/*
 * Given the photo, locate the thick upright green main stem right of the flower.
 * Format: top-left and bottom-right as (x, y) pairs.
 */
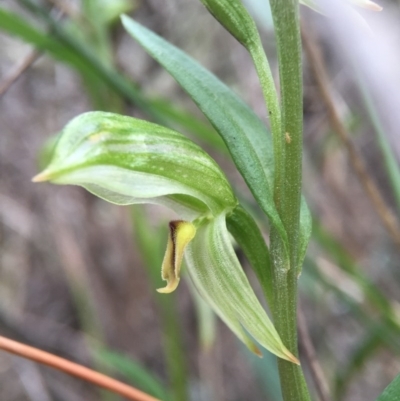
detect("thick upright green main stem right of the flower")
(270, 0), (310, 401)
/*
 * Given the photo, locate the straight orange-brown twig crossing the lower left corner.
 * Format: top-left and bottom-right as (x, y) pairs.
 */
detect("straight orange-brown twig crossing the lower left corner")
(0, 336), (160, 401)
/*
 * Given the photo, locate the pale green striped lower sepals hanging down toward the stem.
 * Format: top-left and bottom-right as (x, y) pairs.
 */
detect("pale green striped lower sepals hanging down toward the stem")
(186, 214), (298, 363)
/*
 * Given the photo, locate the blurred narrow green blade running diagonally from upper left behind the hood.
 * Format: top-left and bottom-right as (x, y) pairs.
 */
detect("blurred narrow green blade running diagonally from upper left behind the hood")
(0, 8), (244, 150)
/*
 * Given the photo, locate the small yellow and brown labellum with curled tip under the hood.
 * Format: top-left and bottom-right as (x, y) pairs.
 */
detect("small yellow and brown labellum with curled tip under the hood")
(157, 220), (196, 293)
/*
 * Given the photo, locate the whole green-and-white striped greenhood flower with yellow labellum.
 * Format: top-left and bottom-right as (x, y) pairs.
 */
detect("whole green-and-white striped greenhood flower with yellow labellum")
(33, 112), (298, 363)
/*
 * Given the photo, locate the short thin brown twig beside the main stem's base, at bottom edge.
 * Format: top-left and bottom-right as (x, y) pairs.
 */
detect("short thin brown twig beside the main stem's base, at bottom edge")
(297, 308), (330, 401)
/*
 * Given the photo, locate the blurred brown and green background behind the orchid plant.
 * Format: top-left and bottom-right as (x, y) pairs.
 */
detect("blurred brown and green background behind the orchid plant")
(0, 0), (400, 401)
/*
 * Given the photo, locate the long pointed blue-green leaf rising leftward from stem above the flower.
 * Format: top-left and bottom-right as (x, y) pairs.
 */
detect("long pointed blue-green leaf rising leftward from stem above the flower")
(122, 15), (286, 243)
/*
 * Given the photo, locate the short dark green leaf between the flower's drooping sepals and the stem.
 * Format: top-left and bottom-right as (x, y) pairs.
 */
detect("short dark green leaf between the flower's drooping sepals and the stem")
(226, 205), (274, 311)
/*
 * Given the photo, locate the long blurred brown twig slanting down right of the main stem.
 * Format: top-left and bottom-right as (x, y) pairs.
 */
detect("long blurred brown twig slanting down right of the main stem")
(301, 26), (400, 246)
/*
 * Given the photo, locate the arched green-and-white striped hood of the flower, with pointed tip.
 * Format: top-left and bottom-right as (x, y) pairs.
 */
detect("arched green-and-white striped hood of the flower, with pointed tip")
(34, 112), (237, 217)
